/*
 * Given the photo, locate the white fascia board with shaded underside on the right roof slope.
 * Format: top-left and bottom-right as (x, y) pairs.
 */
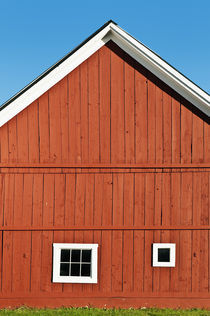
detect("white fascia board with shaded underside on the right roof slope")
(110, 24), (210, 116)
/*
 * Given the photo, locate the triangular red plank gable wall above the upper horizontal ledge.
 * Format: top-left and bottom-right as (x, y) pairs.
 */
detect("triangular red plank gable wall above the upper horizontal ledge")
(1, 44), (210, 164)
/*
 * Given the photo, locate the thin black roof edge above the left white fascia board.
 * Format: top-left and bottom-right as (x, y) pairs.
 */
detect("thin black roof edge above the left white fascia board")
(0, 20), (117, 111)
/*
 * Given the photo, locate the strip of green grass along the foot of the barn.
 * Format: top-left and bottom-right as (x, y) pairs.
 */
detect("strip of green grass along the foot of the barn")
(0, 307), (210, 316)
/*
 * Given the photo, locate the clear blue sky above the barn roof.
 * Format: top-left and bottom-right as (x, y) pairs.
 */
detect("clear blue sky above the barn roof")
(0, 0), (210, 105)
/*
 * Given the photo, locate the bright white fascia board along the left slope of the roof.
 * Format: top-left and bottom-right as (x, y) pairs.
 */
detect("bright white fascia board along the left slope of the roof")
(0, 23), (114, 127)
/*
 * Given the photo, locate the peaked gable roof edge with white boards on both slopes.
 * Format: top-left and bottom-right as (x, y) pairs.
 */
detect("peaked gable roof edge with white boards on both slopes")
(0, 20), (210, 127)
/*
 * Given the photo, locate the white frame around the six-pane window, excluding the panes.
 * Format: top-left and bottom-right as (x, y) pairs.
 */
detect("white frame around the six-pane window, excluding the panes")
(53, 243), (98, 283)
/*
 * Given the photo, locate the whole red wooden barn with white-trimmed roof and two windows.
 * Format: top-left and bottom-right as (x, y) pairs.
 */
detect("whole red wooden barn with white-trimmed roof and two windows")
(0, 21), (210, 308)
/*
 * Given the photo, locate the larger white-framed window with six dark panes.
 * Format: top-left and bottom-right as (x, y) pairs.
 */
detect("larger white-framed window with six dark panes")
(53, 243), (98, 283)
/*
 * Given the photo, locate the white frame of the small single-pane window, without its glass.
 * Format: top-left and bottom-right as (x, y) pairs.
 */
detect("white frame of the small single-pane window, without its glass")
(152, 243), (176, 267)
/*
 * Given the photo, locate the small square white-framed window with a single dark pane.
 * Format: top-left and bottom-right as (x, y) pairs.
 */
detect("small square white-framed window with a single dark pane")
(152, 243), (176, 267)
